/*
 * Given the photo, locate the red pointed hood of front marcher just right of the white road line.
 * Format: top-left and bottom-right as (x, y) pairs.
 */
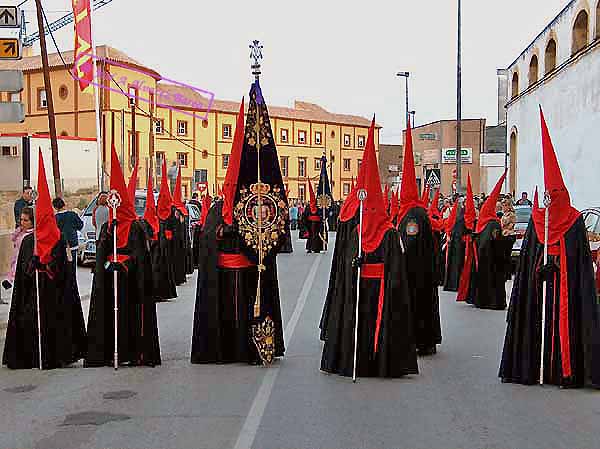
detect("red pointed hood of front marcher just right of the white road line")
(340, 117), (393, 253)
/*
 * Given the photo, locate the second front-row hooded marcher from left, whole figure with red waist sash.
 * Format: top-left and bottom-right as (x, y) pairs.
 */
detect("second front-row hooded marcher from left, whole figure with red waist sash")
(84, 146), (164, 368)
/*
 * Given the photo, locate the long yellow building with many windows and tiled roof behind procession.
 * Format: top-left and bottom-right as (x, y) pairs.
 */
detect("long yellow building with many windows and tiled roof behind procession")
(0, 46), (381, 199)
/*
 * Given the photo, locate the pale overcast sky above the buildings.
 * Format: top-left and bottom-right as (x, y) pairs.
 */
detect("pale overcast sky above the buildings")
(23, 0), (568, 143)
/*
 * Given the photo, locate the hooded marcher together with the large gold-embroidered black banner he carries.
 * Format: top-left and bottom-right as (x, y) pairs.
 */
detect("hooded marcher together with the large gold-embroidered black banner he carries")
(191, 86), (289, 364)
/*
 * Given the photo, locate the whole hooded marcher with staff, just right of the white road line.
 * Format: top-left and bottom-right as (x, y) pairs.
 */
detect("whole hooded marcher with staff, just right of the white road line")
(320, 116), (418, 377)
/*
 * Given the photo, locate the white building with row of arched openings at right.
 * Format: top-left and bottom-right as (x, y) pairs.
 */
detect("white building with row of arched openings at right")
(505, 0), (600, 209)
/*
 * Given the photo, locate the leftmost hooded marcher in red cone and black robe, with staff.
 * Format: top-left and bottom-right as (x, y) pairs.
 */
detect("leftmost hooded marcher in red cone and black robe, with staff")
(2, 151), (86, 369)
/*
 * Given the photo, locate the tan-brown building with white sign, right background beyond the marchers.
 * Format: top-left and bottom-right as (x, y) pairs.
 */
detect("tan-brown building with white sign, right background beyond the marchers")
(402, 119), (485, 195)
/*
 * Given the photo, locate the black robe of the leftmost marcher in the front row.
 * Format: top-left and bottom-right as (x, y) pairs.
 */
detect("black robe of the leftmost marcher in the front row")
(2, 235), (86, 369)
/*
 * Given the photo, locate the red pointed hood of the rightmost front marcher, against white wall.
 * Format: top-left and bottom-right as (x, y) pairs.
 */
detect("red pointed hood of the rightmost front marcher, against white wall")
(533, 106), (581, 245)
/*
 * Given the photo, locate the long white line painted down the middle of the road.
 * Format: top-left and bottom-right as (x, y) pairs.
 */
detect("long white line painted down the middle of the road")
(234, 255), (323, 449)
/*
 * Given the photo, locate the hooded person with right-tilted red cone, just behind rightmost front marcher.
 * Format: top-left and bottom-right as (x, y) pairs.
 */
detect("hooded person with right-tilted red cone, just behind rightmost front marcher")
(469, 170), (506, 310)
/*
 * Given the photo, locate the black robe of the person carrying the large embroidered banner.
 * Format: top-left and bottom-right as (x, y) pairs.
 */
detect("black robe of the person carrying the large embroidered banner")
(191, 201), (285, 364)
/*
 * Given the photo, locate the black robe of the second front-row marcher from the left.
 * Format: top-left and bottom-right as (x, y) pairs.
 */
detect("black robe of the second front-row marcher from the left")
(84, 221), (161, 367)
